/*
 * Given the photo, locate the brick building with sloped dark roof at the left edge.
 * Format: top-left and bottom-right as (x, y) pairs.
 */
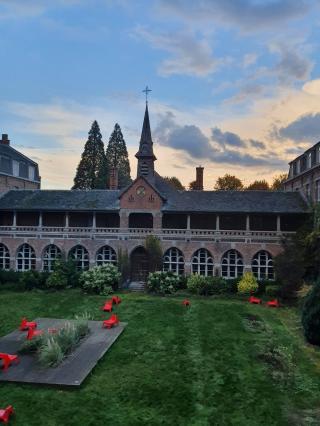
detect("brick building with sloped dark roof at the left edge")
(0, 134), (40, 192)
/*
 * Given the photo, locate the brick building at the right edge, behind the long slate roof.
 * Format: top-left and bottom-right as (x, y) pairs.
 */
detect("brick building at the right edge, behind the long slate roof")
(284, 142), (320, 202)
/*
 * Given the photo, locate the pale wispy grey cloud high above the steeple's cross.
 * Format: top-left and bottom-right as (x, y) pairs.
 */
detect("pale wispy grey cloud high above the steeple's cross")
(133, 27), (223, 77)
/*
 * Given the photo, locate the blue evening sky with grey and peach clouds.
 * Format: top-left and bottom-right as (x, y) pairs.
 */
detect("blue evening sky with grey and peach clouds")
(0, 0), (320, 189)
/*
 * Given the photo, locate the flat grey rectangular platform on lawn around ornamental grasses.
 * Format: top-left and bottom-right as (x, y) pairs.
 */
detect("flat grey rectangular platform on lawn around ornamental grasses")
(0, 318), (127, 386)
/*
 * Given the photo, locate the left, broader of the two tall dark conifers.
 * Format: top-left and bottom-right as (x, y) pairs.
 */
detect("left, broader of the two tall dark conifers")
(72, 121), (106, 189)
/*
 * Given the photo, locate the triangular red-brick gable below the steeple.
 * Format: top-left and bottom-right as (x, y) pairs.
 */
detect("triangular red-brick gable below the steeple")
(120, 177), (163, 210)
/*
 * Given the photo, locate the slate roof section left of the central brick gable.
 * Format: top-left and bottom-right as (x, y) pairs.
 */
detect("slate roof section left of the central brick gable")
(0, 189), (120, 211)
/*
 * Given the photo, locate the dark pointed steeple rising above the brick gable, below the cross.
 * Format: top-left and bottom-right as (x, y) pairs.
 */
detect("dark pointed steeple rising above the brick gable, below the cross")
(136, 102), (157, 178)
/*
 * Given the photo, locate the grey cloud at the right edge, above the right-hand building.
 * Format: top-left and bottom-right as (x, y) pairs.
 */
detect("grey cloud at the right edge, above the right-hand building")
(272, 112), (320, 143)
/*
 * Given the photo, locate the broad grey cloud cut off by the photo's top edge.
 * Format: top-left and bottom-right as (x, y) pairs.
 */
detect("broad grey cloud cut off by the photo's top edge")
(159, 0), (314, 32)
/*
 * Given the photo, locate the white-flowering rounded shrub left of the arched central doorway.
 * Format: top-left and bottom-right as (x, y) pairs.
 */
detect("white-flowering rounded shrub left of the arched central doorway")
(80, 263), (121, 294)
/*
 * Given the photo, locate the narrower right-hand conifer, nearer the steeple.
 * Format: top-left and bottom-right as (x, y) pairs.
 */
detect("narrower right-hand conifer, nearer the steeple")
(106, 123), (131, 188)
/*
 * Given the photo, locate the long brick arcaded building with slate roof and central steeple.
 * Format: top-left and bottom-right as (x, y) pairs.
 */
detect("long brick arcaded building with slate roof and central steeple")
(0, 106), (308, 281)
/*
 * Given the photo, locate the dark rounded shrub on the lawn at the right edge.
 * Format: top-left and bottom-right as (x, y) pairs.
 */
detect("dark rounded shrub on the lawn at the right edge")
(302, 280), (320, 346)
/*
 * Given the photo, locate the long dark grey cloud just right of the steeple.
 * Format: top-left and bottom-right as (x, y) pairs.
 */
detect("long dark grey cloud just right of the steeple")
(154, 112), (286, 167)
